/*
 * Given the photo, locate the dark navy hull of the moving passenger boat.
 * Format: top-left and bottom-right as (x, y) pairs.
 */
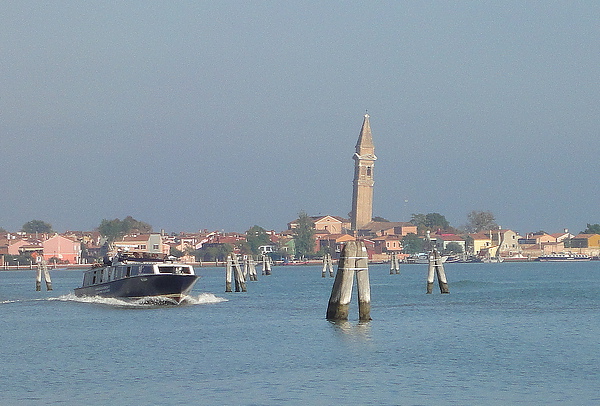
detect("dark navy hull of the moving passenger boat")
(74, 274), (199, 303)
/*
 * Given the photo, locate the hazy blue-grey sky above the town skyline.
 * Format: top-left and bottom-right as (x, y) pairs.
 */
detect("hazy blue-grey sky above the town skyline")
(0, 0), (600, 233)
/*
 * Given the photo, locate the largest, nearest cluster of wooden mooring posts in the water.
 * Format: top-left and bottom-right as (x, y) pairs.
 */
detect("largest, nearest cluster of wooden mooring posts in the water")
(327, 241), (371, 321)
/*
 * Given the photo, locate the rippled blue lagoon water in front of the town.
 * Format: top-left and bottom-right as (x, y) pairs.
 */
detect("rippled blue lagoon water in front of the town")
(0, 262), (600, 405)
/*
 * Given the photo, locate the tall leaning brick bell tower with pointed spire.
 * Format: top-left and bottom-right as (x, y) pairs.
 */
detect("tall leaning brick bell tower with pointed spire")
(350, 114), (377, 231)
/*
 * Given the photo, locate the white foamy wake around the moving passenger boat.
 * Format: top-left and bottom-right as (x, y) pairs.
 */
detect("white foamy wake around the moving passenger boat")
(46, 293), (227, 308)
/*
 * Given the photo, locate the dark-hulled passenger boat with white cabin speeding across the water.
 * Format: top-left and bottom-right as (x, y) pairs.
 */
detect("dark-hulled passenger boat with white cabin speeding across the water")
(74, 254), (199, 304)
